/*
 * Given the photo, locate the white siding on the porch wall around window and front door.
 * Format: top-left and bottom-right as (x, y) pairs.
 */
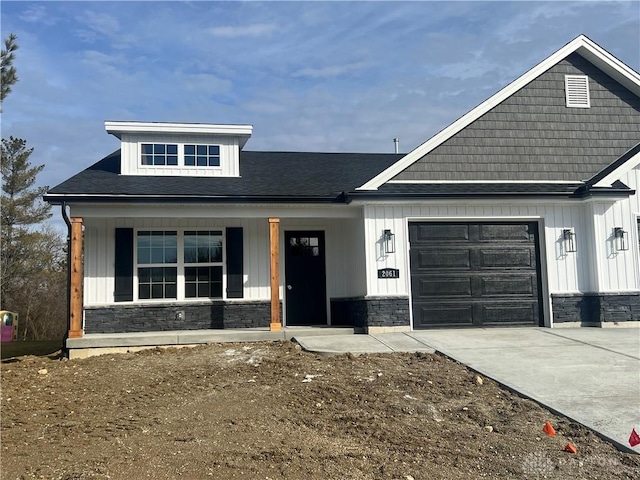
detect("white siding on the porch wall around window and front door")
(84, 217), (366, 306)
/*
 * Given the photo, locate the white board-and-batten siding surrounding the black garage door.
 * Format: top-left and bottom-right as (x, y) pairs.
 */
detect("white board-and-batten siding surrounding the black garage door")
(364, 202), (592, 296)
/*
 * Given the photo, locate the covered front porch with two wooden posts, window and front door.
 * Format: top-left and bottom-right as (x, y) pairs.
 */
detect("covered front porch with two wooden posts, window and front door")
(68, 204), (384, 347)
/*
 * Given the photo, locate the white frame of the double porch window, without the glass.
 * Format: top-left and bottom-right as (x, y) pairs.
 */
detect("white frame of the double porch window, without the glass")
(133, 227), (227, 303)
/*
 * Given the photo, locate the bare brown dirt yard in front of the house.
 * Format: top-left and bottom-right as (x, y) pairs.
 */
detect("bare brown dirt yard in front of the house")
(1, 342), (640, 480)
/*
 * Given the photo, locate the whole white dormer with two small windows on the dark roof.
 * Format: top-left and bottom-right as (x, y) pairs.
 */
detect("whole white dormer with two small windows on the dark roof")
(104, 121), (253, 177)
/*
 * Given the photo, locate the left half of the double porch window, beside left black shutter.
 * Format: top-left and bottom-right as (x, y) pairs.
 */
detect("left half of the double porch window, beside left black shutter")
(137, 231), (178, 300)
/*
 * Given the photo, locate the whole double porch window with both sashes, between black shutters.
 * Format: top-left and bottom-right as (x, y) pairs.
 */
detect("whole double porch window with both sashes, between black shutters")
(136, 230), (223, 300)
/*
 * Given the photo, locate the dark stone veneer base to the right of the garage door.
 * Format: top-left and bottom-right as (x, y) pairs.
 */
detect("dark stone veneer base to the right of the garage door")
(551, 292), (640, 327)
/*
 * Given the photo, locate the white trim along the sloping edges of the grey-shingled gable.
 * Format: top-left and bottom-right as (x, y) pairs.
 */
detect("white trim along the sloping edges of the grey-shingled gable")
(356, 35), (640, 190)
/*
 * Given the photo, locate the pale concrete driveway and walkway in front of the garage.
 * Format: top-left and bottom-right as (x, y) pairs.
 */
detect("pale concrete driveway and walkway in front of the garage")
(295, 328), (640, 453)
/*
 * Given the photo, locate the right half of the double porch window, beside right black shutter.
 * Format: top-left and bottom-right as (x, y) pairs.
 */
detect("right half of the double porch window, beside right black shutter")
(184, 231), (222, 298)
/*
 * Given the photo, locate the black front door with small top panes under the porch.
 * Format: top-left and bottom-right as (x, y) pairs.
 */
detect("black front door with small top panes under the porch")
(284, 231), (327, 326)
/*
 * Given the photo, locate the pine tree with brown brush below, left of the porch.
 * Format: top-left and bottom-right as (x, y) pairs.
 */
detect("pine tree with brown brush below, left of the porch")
(0, 137), (66, 339)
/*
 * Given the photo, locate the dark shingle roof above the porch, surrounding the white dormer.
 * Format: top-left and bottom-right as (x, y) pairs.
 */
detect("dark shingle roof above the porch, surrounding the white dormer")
(45, 150), (403, 202)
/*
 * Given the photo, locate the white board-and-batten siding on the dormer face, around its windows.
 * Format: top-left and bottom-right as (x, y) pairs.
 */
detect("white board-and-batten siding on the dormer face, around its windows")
(121, 133), (240, 177)
